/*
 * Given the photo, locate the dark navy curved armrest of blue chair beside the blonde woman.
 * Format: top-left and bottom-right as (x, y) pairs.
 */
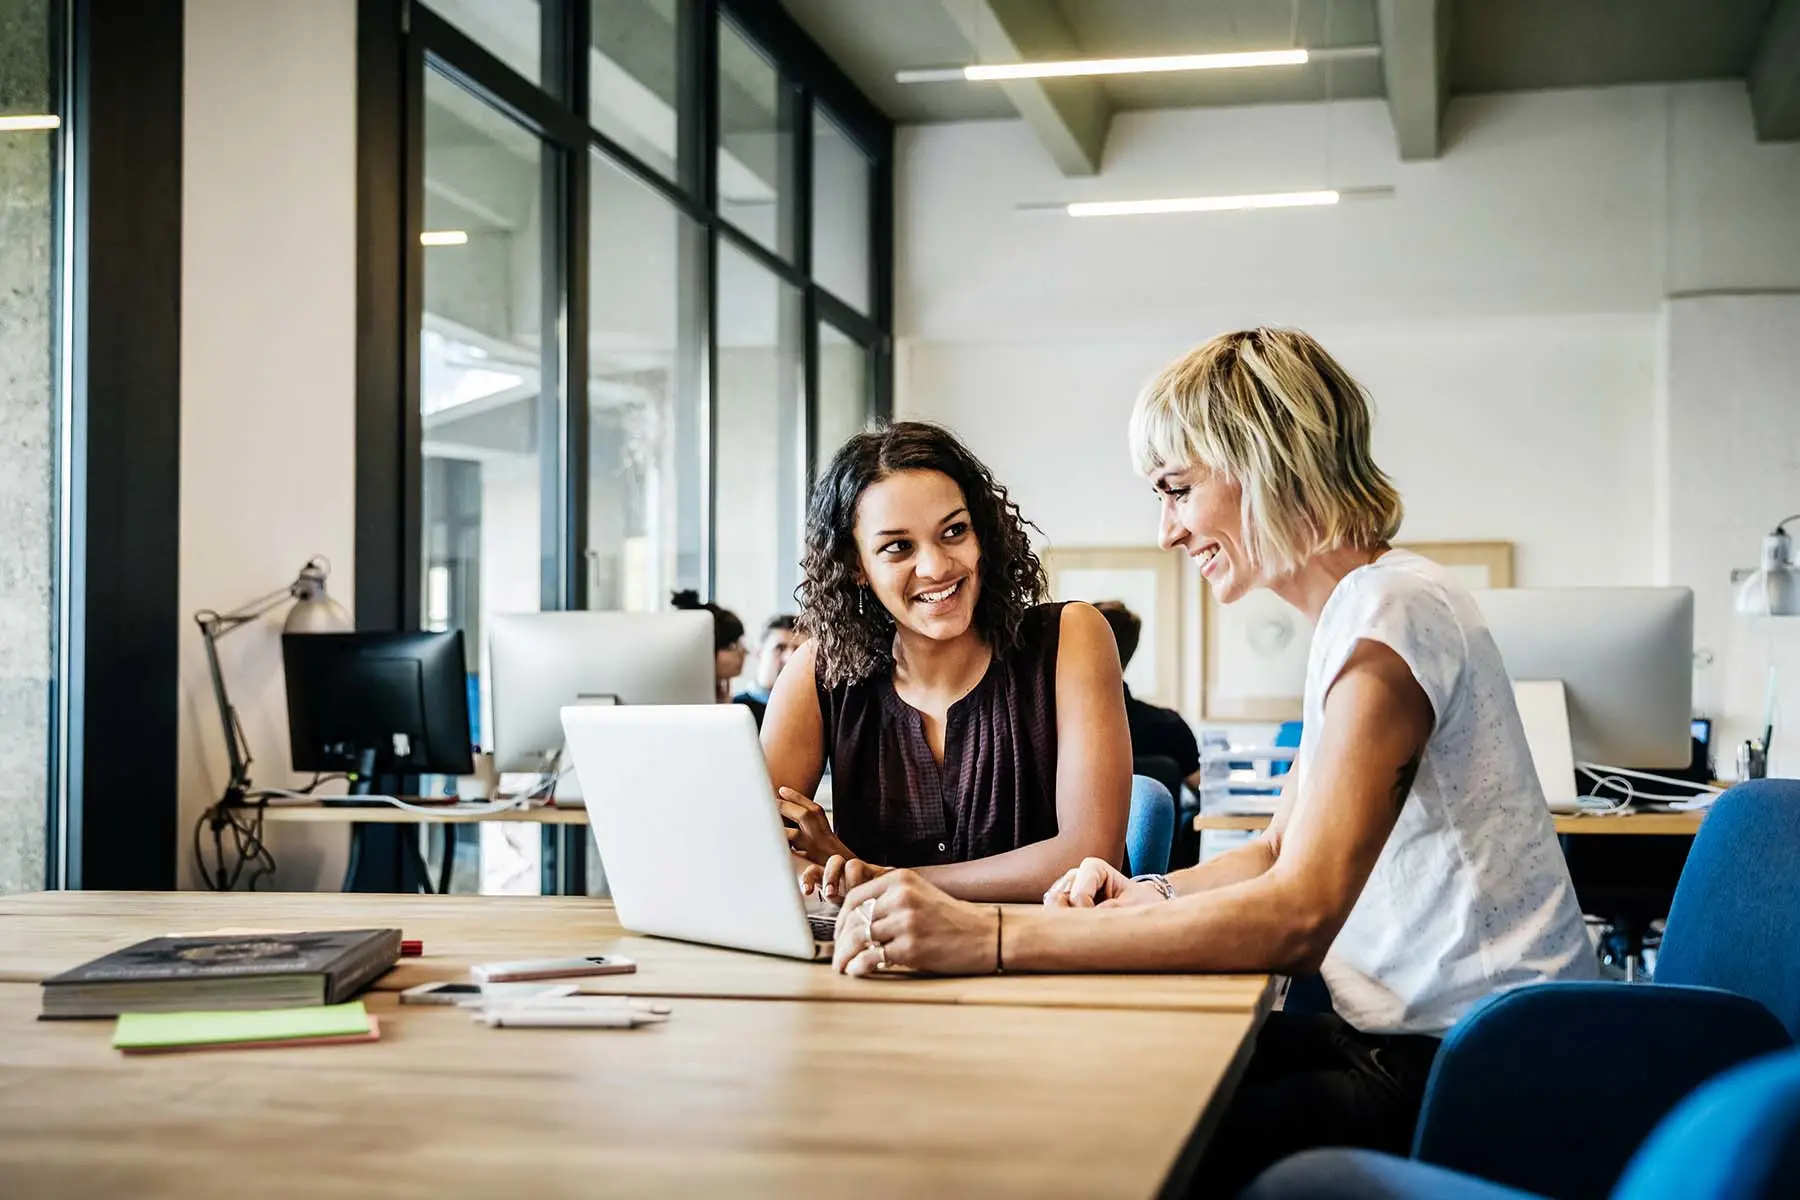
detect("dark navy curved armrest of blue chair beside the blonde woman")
(1413, 982), (1793, 1200)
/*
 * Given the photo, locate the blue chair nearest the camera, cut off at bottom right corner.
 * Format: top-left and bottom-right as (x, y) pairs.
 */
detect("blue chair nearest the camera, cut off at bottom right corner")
(1240, 1051), (1800, 1200)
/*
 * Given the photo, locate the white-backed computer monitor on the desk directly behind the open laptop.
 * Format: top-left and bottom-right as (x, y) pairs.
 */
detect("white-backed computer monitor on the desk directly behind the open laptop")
(488, 612), (716, 772)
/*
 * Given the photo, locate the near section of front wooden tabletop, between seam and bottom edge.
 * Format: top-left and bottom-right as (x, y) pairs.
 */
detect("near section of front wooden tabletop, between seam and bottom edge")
(0, 984), (1255, 1200)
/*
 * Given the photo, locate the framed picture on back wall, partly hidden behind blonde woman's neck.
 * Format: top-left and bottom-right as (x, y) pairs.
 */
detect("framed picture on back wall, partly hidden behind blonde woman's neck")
(1201, 542), (1512, 723)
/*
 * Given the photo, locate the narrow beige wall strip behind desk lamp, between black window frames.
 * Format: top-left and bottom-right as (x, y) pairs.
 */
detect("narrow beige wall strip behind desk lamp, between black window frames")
(178, 0), (356, 891)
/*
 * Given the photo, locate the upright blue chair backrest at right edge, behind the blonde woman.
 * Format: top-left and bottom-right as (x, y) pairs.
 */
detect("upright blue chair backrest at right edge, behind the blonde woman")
(1656, 779), (1800, 1038)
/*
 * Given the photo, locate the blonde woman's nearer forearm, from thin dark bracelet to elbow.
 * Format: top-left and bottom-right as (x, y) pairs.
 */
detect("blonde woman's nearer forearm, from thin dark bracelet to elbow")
(1003, 873), (1330, 973)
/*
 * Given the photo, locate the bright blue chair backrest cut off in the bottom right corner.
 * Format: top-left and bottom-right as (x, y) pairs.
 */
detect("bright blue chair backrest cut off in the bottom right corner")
(1613, 1051), (1800, 1200)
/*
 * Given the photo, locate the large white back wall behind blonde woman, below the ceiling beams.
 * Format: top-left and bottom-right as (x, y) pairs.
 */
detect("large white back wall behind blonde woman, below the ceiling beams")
(896, 83), (1800, 744)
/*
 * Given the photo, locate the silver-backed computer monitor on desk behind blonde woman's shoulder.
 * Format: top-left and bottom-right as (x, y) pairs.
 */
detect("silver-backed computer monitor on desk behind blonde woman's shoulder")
(1474, 588), (1694, 770)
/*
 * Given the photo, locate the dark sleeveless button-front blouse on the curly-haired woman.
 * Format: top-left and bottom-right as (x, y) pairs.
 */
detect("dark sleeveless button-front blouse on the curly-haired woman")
(819, 604), (1062, 867)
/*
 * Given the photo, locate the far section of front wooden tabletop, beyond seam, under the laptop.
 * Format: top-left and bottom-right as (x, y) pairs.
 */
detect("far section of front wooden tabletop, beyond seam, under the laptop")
(0, 892), (1271, 1013)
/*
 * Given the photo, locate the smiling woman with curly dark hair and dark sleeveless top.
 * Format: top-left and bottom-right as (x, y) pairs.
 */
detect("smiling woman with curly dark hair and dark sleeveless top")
(763, 421), (1132, 901)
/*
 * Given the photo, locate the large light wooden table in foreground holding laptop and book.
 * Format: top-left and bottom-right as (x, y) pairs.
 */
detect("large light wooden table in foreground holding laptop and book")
(0, 892), (1269, 1200)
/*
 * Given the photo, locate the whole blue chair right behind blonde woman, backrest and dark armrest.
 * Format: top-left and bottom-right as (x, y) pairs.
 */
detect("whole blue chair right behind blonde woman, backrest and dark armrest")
(1413, 779), (1800, 1200)
